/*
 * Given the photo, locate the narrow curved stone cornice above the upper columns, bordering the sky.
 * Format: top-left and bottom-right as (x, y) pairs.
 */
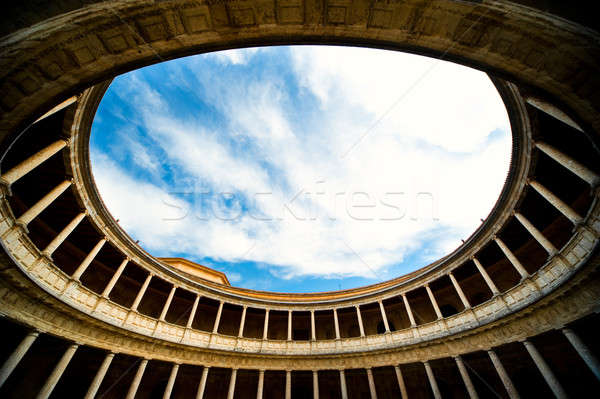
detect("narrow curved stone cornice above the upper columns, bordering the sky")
(65, 78), (533, 310)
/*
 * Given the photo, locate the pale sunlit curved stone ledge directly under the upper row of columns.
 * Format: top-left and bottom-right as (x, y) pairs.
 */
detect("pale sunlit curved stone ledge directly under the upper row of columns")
(0, 183), (600, 356)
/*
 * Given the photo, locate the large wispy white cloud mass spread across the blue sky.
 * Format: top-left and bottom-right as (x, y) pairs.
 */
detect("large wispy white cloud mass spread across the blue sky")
(93, 47), (511, 281)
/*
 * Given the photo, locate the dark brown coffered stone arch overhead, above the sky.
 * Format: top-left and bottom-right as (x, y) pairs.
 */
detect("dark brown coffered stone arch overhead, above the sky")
(0, 0), (600, 142)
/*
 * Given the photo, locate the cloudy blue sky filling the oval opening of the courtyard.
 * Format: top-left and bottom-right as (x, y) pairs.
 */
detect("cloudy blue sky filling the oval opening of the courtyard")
(90, 46), (511, 292)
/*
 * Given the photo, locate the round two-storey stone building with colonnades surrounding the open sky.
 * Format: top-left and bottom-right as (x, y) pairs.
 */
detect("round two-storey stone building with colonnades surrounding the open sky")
(0, 0), (600, 398)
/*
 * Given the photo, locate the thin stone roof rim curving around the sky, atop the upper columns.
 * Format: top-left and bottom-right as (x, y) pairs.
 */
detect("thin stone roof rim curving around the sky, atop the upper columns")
(70, 69), (531, 304)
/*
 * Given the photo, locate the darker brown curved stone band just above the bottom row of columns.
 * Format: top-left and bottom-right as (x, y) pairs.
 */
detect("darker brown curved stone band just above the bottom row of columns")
(0, 239), (600, 370)
